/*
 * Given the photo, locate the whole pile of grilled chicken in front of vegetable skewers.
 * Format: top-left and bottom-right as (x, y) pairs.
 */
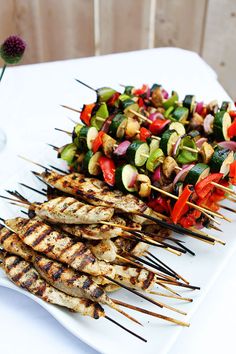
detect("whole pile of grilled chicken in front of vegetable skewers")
(0, 170), (195, 340)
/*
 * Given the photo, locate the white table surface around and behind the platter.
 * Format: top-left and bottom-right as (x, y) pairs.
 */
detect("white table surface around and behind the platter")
(0, 48), (236, 354)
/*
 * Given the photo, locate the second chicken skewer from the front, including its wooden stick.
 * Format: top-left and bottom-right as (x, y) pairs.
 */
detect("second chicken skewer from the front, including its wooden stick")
(0, 225), (188, 326)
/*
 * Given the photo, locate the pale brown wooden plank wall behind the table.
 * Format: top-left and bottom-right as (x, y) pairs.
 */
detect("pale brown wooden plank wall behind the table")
(0, 0), (236, 98)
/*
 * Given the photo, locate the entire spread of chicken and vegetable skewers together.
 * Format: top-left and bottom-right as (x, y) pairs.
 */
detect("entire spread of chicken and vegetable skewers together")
(0, 83), (236, 341)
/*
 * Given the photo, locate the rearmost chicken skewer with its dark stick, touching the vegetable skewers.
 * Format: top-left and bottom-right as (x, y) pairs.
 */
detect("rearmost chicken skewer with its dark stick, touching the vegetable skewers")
(30, 169), (216, 238)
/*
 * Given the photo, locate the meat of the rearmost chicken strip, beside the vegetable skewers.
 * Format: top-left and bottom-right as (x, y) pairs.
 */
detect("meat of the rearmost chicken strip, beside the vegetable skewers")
(41, 171), (152, 214)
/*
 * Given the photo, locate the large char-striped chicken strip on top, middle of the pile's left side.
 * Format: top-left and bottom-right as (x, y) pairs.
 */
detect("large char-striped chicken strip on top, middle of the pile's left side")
(6, 217), (114, 277)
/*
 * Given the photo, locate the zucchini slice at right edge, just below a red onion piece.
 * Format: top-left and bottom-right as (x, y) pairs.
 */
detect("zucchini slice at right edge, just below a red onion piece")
(210, 149), (234, 177)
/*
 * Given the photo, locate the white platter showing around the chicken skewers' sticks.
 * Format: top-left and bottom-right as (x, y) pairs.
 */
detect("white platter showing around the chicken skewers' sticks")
(0, 167), (236, 354)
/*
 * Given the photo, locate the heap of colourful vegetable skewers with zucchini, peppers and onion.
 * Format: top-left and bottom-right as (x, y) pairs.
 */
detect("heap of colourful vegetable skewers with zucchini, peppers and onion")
(57, 80), (236, 229)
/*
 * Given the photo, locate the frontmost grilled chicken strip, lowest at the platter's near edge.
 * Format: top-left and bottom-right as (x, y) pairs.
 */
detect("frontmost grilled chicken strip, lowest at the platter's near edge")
(3, 256), (105, 319)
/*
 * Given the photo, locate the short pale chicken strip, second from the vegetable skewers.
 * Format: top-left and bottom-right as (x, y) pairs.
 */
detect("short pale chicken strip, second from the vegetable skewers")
(34, 196), (114, 224)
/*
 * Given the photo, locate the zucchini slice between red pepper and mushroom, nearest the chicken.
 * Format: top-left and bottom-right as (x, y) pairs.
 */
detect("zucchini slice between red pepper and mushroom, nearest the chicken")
(115, 165), (138, 192)
